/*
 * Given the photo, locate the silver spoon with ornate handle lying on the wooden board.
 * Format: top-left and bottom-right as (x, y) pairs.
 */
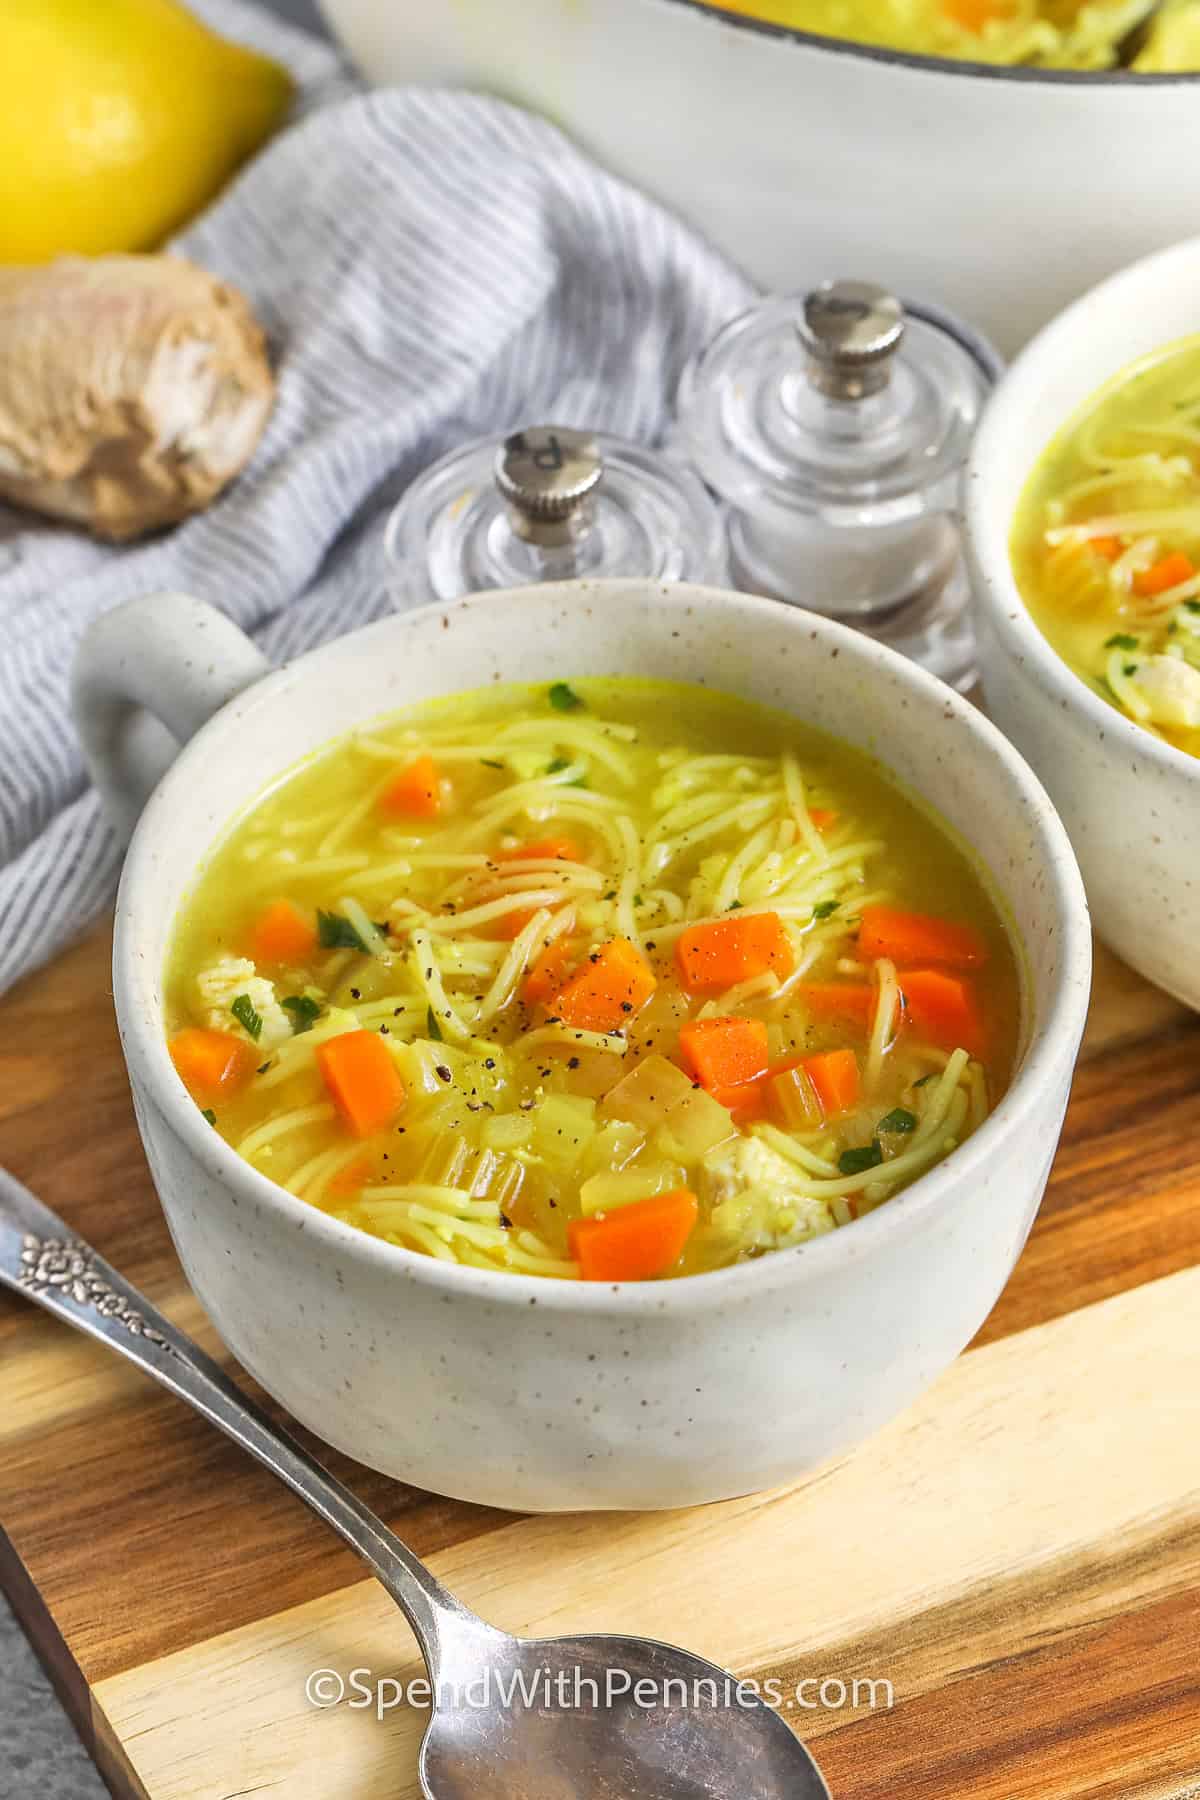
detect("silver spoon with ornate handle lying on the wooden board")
(0, 1170), (829, 1800)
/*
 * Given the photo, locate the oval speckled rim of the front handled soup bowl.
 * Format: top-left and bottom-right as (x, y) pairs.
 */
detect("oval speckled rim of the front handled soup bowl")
(113, 580), (1092, 1318)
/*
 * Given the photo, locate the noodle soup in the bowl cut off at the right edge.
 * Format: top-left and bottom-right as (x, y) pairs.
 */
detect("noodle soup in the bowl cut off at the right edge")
(1013, 337), (1200, 756)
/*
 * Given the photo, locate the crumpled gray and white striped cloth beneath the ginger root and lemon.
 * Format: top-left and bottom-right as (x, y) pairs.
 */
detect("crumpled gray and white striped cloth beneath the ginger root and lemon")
(0, 0), (752, 992)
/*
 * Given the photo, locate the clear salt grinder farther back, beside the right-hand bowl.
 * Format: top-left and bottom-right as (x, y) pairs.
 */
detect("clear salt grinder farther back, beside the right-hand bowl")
(673, 281), (1002, 689)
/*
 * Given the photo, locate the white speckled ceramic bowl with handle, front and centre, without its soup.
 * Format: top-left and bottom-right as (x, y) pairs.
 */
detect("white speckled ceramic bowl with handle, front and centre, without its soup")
(76, 581), (1090, 1510)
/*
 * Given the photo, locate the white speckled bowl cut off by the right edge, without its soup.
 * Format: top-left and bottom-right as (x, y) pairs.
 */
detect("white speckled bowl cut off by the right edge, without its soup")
(966, 238), (1200, 1010)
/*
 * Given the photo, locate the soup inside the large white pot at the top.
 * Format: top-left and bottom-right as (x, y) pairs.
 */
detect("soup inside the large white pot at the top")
(707, 0), (1200, 70)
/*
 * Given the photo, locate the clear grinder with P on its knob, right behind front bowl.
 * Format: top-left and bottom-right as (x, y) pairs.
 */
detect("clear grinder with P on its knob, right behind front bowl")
(385, 425), (727, 605)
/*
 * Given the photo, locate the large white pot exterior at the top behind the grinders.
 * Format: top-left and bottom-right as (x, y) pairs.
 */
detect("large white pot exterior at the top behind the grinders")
(320, 0), (1200, 351)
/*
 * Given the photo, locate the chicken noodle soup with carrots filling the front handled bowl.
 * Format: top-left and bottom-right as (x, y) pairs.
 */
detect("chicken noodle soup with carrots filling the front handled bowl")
(167, 680), (1016, 1282)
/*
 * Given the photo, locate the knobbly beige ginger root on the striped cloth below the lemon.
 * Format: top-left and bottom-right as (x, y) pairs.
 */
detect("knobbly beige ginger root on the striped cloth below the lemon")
(0, 256), (275, 542)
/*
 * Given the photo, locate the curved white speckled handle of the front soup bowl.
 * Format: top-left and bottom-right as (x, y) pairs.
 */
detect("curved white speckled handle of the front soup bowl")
(72, 594), (270, 841)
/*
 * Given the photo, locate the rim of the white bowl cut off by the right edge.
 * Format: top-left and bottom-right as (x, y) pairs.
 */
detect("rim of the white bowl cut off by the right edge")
(964, 238), (1200, 799)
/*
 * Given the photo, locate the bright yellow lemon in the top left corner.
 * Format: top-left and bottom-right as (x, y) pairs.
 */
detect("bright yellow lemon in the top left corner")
(0, 0), (291, 263)
